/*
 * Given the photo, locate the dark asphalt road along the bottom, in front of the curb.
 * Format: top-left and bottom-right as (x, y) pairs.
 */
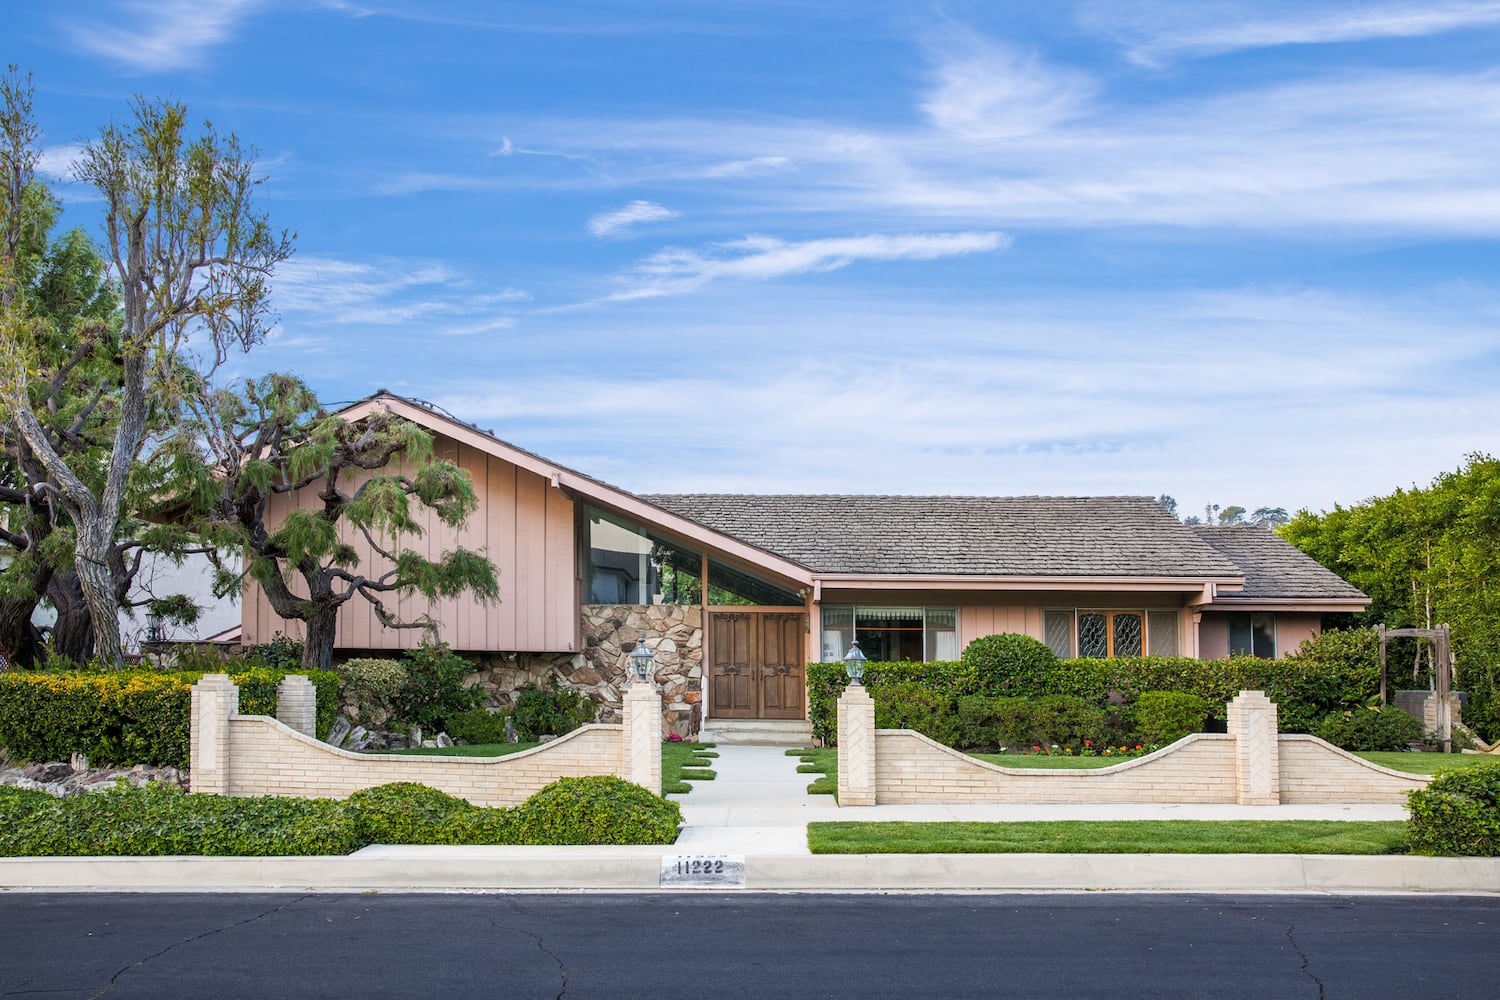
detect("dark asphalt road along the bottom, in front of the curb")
(0, 894), (1500, 1000)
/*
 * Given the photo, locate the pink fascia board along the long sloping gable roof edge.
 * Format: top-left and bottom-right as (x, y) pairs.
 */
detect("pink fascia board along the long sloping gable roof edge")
(339, 396), (813, 586)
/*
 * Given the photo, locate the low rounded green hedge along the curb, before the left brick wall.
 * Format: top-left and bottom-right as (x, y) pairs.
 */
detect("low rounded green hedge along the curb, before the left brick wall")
(0, 777), (683, 858)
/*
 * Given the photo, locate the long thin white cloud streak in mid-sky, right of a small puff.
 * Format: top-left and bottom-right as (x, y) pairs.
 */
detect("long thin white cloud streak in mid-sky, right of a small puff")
(608, 232), (1010, 301)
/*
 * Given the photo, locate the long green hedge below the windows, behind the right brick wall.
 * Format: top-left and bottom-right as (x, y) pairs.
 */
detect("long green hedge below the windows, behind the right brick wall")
(807, 628), (1380, 745)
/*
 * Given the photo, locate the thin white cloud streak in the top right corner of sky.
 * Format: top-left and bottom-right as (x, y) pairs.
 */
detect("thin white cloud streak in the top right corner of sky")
(1086, 0), (1500, 64)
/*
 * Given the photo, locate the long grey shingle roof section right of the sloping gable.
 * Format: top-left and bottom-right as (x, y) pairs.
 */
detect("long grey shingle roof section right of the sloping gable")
(642, 493), (1242, 577)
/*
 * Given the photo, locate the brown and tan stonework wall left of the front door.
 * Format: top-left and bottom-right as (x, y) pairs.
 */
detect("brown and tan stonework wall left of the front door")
(467, 604), (704, 738)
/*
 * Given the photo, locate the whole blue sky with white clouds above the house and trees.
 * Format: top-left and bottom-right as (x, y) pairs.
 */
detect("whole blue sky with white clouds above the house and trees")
(5, 0), (1500, 513)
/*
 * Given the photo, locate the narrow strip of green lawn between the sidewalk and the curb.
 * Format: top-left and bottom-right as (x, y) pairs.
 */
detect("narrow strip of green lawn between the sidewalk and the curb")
(807, 820), (1406, 855)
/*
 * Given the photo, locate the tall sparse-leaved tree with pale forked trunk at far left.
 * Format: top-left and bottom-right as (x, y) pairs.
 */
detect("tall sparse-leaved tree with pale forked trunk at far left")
(0, 78), (291, 664)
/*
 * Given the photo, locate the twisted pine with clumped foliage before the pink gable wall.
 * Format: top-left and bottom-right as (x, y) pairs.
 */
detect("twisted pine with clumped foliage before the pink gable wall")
(164, 375), (500, 669)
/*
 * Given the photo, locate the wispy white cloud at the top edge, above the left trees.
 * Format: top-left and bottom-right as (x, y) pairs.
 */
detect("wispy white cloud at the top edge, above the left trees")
(60, 0), (266, 73)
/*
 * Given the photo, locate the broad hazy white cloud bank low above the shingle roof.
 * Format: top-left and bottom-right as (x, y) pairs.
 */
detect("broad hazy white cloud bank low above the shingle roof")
(440, 286), (1500, 513)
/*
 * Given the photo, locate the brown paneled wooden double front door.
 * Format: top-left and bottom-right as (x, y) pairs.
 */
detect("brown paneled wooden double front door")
(708, 610), (807, 718)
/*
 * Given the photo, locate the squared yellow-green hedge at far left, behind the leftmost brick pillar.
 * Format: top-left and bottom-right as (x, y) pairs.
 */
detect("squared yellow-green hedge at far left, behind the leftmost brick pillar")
(0, 664), (339, 768)
